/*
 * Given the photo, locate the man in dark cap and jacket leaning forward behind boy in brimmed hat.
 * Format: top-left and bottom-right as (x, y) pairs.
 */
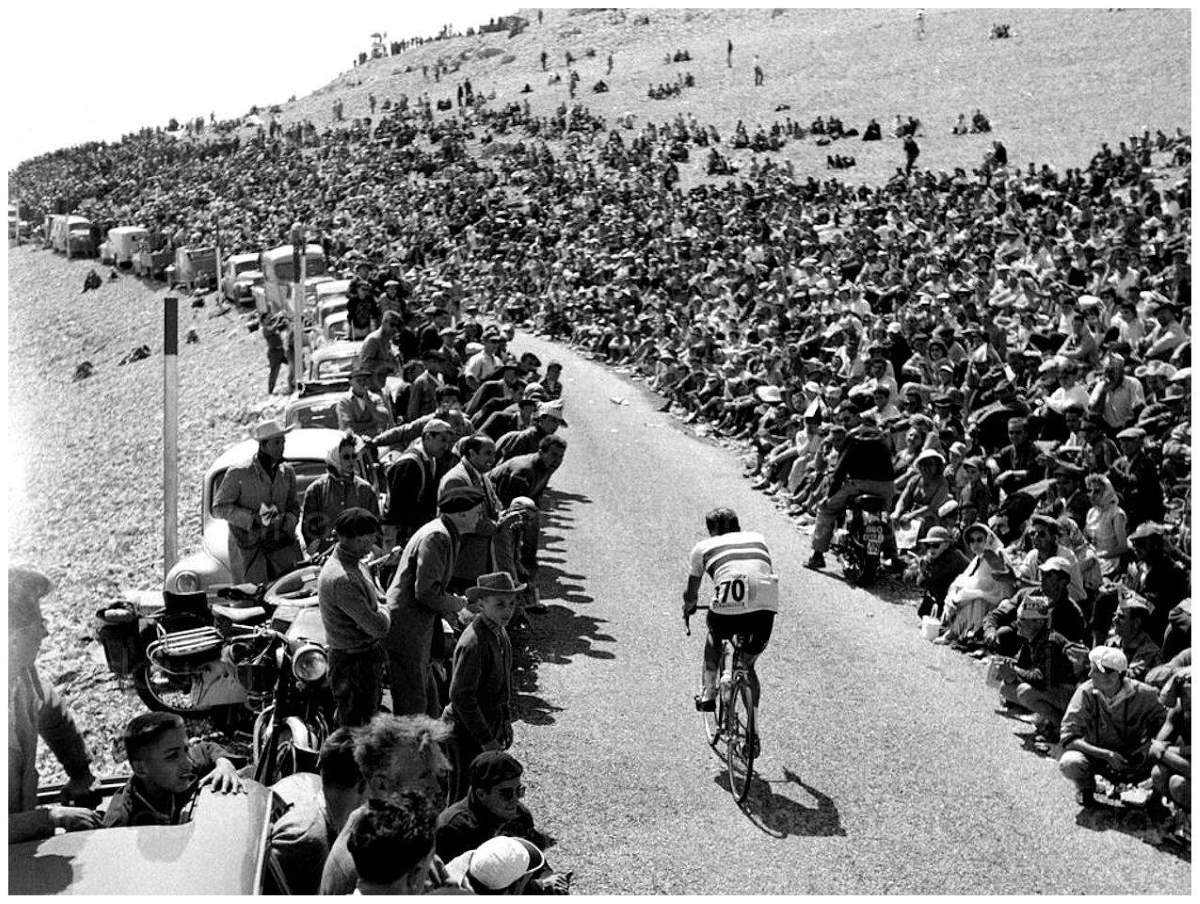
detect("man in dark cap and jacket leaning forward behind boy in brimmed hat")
(384, 486), (484, 718)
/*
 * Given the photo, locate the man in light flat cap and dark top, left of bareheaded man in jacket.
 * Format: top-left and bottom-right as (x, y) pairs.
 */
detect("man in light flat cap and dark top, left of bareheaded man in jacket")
(383, 418), (457, 547)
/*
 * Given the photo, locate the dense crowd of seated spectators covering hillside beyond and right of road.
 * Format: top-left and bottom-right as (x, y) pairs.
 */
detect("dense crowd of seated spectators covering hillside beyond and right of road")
(11, 52), (1190, 845)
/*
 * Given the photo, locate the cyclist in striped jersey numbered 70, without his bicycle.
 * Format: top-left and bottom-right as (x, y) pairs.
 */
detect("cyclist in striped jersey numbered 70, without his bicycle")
(683, 508), (779, 712)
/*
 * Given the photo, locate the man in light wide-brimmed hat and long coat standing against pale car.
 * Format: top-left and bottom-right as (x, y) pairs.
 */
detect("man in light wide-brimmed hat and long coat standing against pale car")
(212, 420), (304, 583)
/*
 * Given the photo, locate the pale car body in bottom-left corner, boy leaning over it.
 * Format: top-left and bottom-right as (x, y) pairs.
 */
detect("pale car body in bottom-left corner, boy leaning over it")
(8, 779), (287, 897)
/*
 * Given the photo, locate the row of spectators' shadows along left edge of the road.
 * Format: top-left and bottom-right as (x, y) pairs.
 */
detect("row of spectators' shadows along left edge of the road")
(512, 490), (616, 725)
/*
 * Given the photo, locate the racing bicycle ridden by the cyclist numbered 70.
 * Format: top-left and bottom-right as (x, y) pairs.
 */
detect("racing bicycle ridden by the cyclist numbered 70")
(683, 606), (758, 803)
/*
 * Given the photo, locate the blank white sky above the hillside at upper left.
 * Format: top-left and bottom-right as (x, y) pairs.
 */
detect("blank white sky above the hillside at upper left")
(0, 0), (511, 170)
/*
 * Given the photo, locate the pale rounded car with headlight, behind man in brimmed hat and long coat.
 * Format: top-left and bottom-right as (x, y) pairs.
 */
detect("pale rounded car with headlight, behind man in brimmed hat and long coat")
(163, 429), (350, 593)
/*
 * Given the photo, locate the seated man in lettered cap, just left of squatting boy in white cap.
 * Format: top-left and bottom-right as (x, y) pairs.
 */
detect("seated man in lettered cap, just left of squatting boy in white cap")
(1000, 593), (1082, 743)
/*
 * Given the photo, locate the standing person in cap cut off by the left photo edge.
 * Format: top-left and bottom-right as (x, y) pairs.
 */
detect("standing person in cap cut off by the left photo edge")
(8, 565), (101, 844)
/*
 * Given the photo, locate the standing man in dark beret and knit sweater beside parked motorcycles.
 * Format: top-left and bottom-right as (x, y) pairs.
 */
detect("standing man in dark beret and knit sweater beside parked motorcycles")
(317, 508), (391, 726)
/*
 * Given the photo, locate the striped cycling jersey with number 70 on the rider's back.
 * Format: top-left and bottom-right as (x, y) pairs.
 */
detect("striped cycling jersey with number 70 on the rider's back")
(689, 531), (779, 615)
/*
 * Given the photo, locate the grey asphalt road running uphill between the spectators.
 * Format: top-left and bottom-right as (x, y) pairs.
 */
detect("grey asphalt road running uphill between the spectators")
(501, 336), (1190, 894)
